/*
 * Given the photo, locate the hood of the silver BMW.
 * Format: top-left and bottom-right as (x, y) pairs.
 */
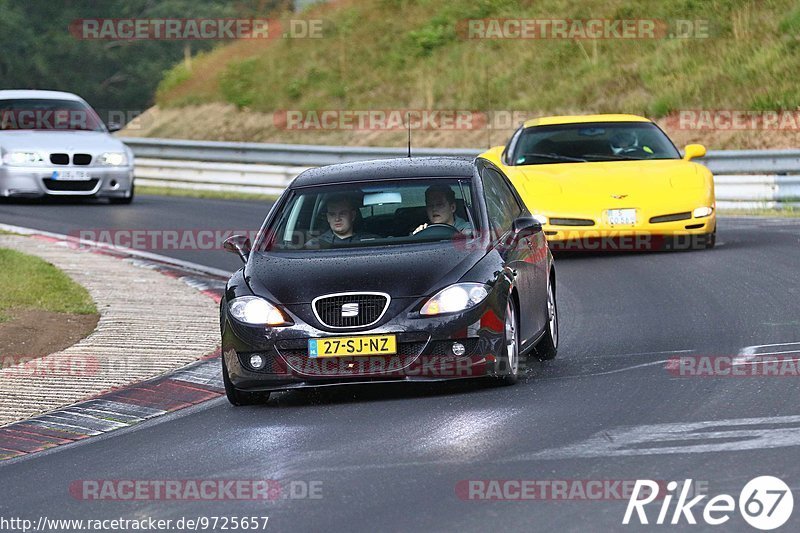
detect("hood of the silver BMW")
(0, 130), (127, 154)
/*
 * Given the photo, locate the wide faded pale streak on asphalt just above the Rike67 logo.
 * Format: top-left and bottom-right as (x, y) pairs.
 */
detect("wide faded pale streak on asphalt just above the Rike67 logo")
(514, 416), (800, 460)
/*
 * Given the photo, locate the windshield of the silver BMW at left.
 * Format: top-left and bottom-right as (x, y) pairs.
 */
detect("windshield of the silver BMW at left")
(0, 98), (106, 131)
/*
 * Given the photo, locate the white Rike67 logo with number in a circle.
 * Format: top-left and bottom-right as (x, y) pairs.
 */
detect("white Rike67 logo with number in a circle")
(622, 476), (794, 531)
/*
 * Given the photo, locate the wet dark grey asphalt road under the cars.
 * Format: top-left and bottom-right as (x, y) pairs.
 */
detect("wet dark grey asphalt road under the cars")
(0, 196), (800, 531)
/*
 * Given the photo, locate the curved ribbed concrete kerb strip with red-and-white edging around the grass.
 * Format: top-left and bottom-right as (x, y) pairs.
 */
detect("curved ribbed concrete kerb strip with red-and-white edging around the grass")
(0, 224), (229, 461)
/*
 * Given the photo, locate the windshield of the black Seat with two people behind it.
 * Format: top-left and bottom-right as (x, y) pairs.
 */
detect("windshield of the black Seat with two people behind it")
(256, 178), (476, 252)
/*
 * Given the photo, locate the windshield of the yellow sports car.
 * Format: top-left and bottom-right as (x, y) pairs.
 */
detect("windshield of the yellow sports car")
(508, 122), (680, 165)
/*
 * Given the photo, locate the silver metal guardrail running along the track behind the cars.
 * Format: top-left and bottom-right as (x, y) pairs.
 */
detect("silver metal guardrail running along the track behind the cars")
(122, 138), (800, 208)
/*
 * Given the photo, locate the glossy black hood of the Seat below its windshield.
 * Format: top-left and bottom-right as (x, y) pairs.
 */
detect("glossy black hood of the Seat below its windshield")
(245, 245), (486, 304)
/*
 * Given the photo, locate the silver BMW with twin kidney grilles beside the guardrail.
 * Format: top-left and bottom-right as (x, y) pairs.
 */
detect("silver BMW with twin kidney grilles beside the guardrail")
(0, 90), (134, 204)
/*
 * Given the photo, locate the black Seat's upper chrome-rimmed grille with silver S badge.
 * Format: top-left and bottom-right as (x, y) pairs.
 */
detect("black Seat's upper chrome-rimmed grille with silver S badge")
(311, 293), (389, 328)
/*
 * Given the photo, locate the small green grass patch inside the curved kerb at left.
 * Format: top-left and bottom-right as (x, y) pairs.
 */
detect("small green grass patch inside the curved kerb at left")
(0, 248), (97, 322)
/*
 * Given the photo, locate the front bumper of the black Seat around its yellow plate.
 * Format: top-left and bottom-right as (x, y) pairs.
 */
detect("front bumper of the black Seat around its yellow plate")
(221, 294), (507, 392)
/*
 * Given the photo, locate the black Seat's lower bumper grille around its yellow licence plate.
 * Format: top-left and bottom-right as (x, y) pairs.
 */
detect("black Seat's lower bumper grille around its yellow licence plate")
(278, 342), (425, 378)
